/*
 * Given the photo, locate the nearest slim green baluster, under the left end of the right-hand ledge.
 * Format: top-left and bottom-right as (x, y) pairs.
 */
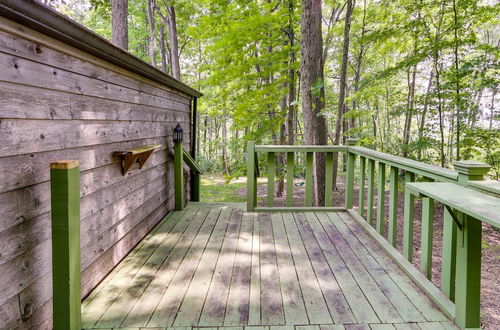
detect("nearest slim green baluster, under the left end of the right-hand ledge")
(420, 197), (434, 280)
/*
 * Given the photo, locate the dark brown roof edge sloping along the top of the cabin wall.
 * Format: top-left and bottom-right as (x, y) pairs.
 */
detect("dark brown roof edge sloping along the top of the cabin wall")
(0, 0), (203, 97)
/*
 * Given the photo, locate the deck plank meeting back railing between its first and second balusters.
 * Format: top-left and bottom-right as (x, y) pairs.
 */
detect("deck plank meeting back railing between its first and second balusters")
(271, 213), (309, 325)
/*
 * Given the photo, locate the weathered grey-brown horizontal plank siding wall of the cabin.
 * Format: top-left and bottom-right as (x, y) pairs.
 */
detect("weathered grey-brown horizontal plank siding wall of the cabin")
(0, 17), (190, 329)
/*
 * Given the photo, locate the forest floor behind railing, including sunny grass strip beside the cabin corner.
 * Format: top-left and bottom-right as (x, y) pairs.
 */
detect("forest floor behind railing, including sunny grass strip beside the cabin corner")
(201, 176), (500, 329)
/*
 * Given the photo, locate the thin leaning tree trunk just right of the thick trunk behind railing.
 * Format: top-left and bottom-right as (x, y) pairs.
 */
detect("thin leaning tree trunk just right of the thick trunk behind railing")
(333, 0), (353, 189)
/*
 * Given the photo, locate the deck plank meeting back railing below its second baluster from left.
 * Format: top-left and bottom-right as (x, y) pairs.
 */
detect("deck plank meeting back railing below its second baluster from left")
(283, 213), (333, 324)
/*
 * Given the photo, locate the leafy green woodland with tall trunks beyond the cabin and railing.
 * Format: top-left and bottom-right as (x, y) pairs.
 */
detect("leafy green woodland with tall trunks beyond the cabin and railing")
(45, 0), (500, 191)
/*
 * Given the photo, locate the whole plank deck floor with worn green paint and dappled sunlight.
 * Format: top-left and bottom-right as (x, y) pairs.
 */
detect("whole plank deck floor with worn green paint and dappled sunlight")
(82, 203), (454, 330)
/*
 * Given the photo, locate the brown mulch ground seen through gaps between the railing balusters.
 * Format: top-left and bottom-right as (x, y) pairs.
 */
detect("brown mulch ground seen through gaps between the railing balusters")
(238, 182), (500, 329)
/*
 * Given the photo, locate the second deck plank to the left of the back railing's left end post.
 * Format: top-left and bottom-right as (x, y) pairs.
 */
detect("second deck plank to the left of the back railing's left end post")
(173, 208), (231, 326)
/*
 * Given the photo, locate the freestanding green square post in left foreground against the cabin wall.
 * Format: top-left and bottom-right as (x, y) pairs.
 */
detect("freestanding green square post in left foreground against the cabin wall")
(50, 160), (81, 330)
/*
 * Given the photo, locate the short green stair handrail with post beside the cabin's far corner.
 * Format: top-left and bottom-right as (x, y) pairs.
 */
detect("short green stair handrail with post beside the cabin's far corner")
(174, 143), (202, 211)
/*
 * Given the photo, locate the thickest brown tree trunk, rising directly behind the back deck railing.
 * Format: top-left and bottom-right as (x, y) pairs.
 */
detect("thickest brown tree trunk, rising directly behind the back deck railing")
(300, 0), (328, 206)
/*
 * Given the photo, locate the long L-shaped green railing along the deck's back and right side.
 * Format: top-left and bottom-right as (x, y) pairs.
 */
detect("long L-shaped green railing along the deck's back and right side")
(247, 139), (500, 328)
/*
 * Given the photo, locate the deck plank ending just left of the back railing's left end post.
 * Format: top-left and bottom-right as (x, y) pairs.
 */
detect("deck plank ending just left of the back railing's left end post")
(198, 209), (242, 326)
